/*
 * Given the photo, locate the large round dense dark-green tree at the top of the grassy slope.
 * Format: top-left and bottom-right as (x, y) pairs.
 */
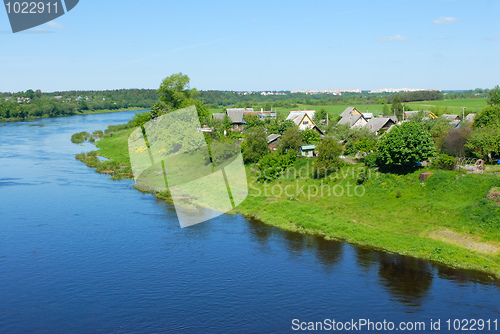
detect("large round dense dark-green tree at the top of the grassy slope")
(378, 122), (435, 167)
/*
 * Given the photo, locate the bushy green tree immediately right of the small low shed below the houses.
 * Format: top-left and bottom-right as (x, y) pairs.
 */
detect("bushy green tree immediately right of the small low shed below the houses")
(313, 137), (343, 178)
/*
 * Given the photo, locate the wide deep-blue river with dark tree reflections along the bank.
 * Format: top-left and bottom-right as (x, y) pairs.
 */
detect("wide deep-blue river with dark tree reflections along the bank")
(0, 112), (500, 333)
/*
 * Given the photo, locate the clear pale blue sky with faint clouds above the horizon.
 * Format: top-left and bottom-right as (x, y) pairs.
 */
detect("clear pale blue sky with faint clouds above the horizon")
(0, 0), (500, 92)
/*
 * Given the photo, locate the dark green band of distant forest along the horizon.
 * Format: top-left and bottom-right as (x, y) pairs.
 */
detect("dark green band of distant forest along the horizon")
(0, 88), (489, 120)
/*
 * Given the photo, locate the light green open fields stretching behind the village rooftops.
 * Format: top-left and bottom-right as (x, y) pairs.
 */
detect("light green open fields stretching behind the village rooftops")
(210, 98), (487, 120)
